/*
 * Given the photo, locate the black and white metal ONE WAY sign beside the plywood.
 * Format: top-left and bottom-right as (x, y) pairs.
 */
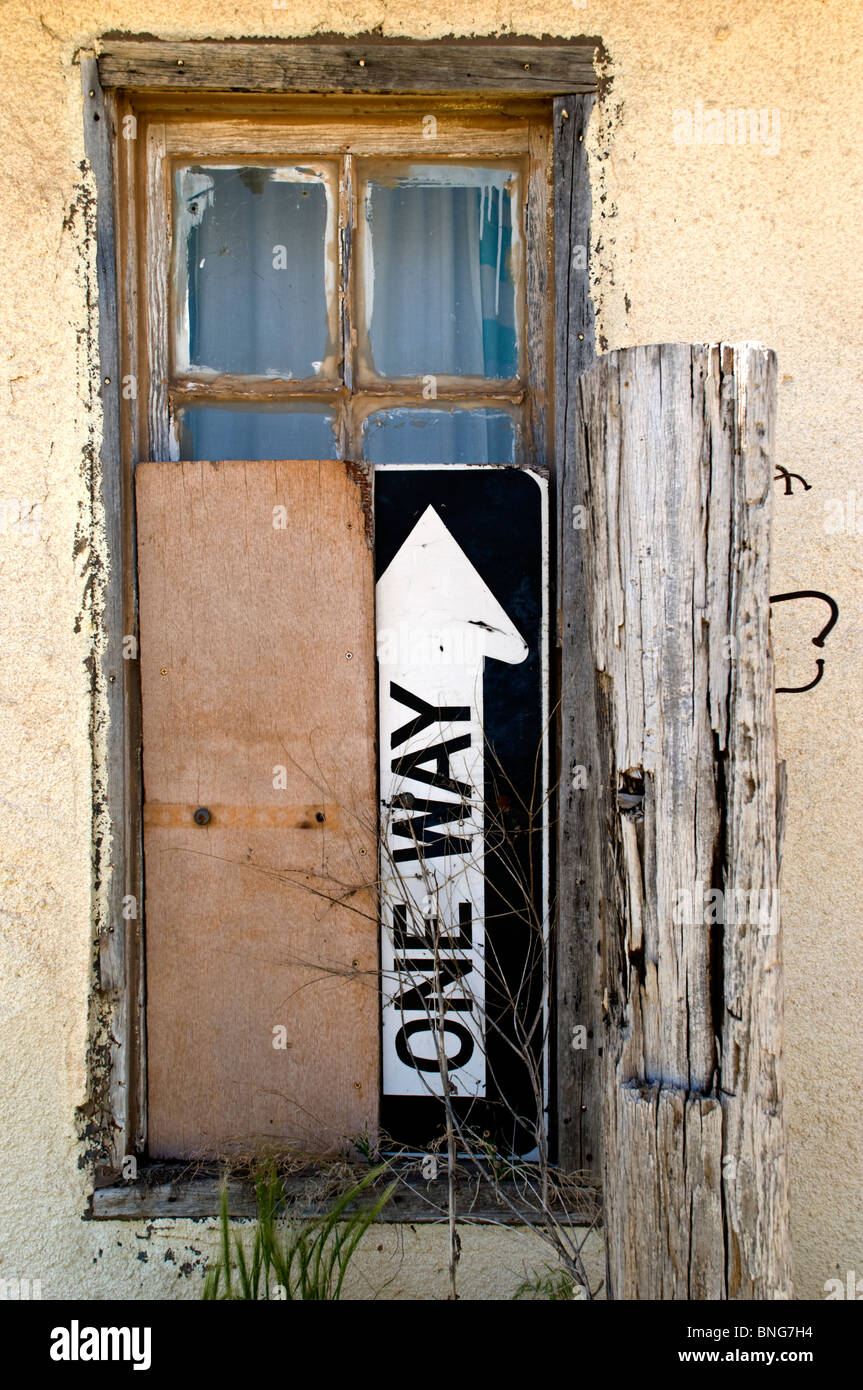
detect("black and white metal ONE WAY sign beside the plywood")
(375, 466), (548, 1143)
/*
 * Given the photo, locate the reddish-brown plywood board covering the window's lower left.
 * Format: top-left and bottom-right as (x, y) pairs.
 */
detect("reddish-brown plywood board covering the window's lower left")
(136, 461), (378, 1158)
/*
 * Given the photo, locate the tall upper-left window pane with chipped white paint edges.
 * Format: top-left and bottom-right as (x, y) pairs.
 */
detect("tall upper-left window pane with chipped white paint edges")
(174, 165), (336, 378)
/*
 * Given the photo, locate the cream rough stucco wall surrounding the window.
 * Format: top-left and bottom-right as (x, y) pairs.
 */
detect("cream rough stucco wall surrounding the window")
(0, 0), (863, 1298)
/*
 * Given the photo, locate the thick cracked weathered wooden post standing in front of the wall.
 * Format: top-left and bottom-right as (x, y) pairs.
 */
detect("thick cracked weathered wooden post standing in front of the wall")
(564, 343), (791, 1298)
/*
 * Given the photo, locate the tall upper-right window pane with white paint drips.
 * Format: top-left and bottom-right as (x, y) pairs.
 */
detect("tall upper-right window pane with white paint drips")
(361, 164), (521, 378)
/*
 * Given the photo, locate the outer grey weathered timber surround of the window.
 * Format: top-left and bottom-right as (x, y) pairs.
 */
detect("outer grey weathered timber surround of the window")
(81, 39), (600, 1220)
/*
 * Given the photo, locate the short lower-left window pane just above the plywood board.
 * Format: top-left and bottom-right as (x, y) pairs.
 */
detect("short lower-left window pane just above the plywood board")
(176, 402), (336, 459)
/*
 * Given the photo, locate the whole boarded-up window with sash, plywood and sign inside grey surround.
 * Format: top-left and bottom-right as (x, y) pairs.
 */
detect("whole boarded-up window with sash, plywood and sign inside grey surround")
(131, 99), (552, 1158)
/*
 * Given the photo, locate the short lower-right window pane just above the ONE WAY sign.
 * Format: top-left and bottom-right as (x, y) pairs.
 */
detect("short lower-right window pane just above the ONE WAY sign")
(363, 407), (516, 464)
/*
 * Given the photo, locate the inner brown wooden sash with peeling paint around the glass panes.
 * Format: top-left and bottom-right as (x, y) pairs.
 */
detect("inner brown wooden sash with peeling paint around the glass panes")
(136, 93), (552, 468)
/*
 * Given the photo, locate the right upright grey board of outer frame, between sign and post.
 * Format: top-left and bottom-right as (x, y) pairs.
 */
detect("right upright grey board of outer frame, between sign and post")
(553, 93), (605, 1183)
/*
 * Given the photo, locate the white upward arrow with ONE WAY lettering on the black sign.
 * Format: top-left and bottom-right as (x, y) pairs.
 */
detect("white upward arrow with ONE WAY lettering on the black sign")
(377, 506), (528, 1097)
